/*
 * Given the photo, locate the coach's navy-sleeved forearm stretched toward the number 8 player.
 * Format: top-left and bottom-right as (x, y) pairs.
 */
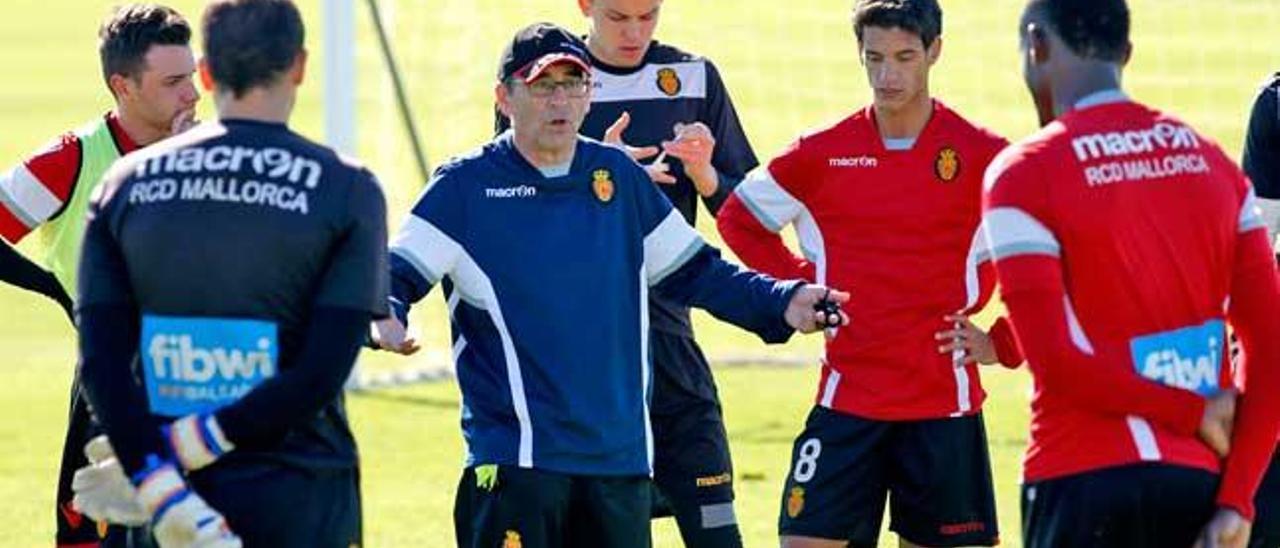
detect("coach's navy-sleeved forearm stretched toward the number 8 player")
(654, 246), (803, 343)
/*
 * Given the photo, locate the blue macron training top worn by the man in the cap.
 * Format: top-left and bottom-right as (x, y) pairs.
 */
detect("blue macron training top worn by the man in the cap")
(390, 132), (797, 475)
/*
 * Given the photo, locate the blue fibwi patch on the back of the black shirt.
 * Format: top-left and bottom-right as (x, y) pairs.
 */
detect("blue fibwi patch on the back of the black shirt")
(138, 315), (279, 416)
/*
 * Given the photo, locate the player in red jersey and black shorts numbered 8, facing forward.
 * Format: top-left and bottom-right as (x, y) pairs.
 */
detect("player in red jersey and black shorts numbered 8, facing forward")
(717, 0), (1021, 547)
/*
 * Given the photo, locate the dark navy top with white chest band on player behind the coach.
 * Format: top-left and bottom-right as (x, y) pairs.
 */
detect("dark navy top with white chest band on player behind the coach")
(498, 41), (759, 337)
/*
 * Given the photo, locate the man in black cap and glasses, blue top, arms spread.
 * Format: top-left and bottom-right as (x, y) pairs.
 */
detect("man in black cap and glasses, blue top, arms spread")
(376, 23), (849, 548)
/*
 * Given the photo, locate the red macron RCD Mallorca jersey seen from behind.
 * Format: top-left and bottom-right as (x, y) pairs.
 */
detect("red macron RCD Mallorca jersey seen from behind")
(984, 92), (1274, 491)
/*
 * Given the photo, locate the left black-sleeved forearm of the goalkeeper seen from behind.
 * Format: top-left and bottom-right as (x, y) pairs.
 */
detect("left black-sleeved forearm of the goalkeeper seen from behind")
(79, 305), (168, 476)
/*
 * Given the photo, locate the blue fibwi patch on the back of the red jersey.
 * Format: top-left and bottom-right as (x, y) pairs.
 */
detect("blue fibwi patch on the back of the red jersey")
(1129, 320), (1226, 397)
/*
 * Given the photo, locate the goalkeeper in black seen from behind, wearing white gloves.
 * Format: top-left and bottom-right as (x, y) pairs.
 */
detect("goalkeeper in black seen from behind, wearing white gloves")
(76, 0), (387, 548)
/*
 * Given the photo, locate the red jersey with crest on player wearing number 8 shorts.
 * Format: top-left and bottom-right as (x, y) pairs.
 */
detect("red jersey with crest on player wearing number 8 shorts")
(717, 101), (1007, 420)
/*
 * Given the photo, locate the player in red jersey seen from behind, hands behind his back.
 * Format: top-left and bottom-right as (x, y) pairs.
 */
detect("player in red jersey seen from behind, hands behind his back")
(983, 0), (1280, 548)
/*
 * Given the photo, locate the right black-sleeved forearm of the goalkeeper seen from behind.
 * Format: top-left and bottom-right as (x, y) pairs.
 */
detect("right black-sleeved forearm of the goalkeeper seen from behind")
(215, 307), (371, 448)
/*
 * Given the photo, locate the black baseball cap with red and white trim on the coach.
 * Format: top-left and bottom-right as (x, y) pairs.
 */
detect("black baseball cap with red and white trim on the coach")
(498, 23), (591, 83)
